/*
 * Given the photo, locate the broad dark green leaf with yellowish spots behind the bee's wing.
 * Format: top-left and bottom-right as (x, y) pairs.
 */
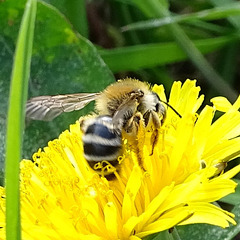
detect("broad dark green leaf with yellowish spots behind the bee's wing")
(0, 0), (115, 172)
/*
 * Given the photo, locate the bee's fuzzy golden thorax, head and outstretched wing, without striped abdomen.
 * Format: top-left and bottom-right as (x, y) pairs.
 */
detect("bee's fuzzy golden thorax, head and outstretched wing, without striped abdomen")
(26, 78), (166, 134)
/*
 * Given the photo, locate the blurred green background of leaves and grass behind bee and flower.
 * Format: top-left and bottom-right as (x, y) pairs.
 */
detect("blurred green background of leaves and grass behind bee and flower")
(0, 0), (240, 240)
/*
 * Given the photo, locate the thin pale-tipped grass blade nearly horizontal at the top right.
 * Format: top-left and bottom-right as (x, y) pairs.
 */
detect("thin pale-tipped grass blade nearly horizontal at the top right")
(122, 3), (240, 31)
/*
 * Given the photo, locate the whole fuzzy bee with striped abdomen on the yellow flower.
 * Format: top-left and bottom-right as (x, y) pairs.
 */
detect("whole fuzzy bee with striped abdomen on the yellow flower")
(26, 78), (180, 176)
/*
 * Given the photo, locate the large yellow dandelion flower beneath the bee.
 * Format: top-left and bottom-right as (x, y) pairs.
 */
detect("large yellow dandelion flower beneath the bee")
(0, 80), (240, 240)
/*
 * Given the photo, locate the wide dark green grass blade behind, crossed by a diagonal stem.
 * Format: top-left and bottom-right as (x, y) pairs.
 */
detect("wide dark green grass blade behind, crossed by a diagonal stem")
(99, 36), (237, 72)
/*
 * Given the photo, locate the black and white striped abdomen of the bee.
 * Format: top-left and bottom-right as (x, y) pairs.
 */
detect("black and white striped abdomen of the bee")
(82, 115), (122, 175)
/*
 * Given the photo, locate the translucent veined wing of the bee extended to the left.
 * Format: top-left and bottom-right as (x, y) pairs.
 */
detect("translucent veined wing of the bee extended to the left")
(26, 93), (100, 121)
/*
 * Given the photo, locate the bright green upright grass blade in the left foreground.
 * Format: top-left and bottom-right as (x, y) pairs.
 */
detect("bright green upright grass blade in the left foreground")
(6, 0), (37, 240)
